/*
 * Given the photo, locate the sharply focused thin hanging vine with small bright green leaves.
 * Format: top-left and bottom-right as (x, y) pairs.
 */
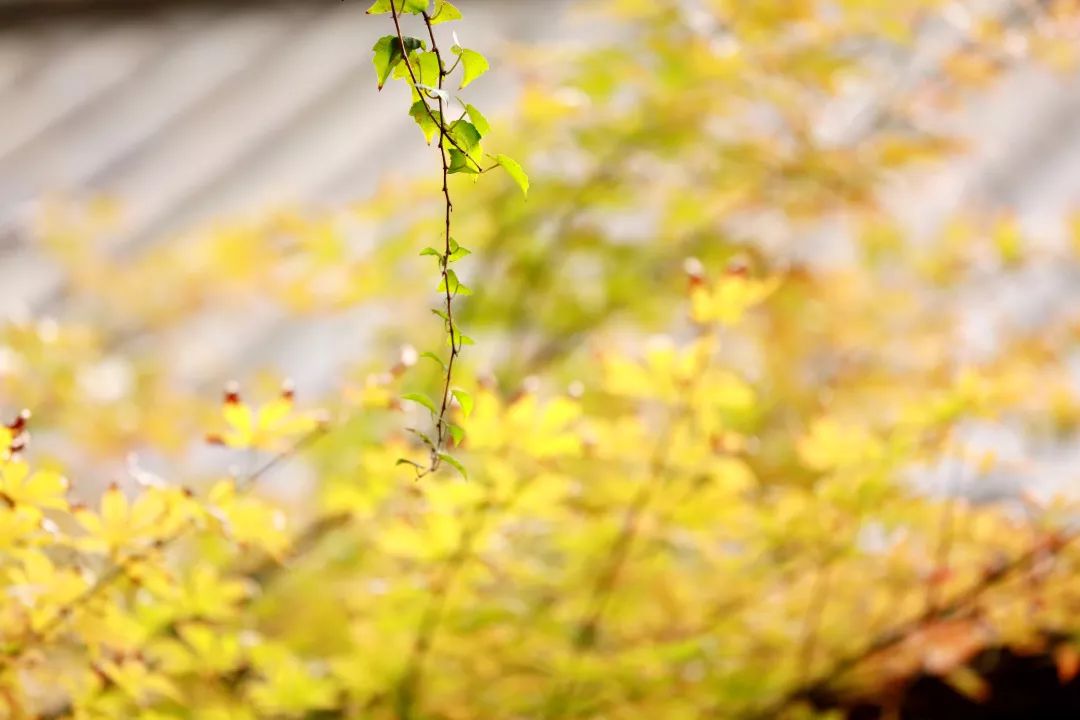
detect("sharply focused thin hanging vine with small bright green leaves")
(367, 0), (529, 479)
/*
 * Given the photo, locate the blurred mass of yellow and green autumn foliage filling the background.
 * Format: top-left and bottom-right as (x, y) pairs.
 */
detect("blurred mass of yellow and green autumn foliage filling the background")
(0, 0), (1080, 720)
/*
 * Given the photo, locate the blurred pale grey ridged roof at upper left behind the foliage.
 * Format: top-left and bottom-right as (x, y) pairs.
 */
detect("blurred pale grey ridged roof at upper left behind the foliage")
(0, 0), (562, 397)
